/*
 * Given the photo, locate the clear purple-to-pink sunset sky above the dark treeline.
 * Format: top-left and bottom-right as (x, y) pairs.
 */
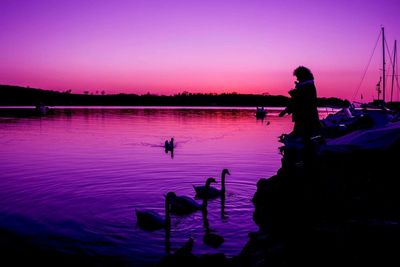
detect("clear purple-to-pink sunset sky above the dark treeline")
(0, 0), (400, 100)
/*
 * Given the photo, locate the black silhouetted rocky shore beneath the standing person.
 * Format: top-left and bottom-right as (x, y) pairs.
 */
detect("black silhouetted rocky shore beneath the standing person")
(161, 129), (400, 267)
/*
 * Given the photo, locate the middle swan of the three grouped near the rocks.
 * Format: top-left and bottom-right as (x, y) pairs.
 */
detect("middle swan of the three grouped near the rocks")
(169, 178), (216, 215)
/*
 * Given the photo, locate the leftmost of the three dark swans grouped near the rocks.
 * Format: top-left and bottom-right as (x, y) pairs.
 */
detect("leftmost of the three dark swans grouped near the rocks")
(135, 193), (173, 230)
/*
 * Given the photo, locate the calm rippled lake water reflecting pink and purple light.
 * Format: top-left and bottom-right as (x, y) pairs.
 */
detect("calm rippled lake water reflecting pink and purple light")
(0, 108), (300, 266)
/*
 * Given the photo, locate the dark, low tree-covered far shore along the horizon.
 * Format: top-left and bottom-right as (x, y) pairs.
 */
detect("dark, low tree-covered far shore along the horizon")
(0, 85), (345, 107)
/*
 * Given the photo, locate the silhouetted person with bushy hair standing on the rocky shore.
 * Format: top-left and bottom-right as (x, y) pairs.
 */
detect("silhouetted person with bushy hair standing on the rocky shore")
(279, 66), (320, 143)
